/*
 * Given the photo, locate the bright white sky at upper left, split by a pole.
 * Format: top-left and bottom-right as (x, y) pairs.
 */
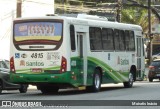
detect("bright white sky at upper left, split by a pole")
(0, 0), (54, 59)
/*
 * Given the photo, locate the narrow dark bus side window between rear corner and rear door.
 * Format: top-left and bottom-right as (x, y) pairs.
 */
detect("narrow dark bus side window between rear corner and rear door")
(70, 25), (76, 51)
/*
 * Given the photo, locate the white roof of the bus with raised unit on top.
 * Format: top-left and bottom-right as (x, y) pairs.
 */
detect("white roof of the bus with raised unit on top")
(15, 14), (142, 31)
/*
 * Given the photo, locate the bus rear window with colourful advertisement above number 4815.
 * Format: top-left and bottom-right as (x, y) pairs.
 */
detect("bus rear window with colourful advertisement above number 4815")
(13, 21), (63, 51)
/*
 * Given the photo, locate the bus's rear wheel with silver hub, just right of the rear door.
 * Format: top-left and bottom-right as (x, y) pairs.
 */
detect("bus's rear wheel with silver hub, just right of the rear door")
(91, 69), (101, 92)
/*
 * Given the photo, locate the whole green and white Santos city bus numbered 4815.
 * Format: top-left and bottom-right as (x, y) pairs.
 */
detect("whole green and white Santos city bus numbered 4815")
(10, 14), (145, 93)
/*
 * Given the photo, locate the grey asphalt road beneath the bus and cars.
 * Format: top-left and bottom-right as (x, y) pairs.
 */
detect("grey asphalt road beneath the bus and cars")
(0, 80), (160, 109)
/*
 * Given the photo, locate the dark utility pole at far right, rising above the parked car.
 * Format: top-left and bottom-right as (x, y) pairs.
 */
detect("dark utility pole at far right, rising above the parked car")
(148, 0), (152, 64)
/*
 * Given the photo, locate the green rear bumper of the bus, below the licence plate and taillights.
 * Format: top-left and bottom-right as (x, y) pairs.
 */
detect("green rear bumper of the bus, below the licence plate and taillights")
(10, 71), (75, 86)
